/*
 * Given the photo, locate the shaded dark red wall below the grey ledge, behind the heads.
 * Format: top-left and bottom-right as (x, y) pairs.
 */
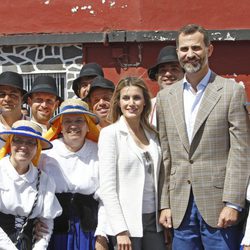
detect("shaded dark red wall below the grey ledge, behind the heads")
(83, 41), (250, 101)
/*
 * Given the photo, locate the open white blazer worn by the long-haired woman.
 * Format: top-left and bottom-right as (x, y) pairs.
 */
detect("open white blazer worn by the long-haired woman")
(98, 116), (161, 237)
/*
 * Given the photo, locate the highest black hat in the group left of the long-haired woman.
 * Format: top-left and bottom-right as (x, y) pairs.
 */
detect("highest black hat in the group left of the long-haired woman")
(72, 63), (104, 96)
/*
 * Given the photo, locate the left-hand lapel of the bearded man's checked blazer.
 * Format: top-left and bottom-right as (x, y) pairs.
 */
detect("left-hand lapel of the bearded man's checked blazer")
(168, 81), (190, 152)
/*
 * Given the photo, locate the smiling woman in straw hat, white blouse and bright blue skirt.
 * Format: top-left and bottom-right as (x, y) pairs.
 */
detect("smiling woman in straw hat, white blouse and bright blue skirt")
(38, 99), (104, 250)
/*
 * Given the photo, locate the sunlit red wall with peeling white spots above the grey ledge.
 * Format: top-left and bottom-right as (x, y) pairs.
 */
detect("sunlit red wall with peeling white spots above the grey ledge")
(0, 0), (250, 34)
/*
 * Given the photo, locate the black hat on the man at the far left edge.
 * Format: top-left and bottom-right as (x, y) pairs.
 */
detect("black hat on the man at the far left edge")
(0, 71), (27, 95)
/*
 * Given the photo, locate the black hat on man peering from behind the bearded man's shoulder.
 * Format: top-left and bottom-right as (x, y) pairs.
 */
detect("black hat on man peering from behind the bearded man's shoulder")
(148, 46), (179, 80)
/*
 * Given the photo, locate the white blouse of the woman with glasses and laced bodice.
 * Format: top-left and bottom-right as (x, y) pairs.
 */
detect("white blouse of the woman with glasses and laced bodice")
(0, 156), (62, 249)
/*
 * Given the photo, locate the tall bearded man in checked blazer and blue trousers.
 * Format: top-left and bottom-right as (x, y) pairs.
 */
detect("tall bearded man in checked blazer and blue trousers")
(157, 24), (250, 250)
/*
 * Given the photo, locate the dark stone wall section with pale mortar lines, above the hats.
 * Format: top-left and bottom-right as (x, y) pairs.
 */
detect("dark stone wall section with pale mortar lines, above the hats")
(0, 44), (82, 98)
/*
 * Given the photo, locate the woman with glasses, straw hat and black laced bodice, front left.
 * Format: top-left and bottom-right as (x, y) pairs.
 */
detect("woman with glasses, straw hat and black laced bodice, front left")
(0, 120), (62, 250)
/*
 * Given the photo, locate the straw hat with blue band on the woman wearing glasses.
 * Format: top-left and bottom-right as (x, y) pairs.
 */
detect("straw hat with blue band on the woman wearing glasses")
(0, 120), (53, 149)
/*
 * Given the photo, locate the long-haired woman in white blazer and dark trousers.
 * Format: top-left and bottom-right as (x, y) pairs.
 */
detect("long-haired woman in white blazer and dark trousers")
(98, 77), (165, 250)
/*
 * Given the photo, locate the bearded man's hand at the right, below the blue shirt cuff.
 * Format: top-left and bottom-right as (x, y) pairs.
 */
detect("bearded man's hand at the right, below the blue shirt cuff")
(217, 207), (239, 228)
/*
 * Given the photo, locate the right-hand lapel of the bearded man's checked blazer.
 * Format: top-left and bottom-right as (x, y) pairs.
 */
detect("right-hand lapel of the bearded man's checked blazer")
(192, 72), (222, 142)
